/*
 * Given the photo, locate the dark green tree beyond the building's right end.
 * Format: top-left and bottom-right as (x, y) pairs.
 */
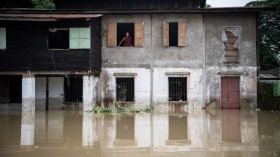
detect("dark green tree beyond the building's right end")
(246, 0), (280, 70)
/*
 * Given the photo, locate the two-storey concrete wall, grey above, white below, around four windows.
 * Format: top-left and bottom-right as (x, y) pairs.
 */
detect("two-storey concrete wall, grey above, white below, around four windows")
(100, 14), (205, 108)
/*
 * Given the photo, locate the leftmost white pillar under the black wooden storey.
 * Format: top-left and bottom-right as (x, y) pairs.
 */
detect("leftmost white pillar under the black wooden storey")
(22, 74), (35, 111)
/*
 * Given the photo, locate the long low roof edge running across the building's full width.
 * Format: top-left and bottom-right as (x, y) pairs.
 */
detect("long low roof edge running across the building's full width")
(0, 7), (275, 21)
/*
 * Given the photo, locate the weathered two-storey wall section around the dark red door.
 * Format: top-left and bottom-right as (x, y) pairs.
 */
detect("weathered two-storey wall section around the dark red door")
(204, 13), (257, 108)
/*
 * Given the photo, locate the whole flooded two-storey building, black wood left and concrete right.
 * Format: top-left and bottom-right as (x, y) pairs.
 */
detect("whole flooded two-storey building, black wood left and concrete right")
(0, 0), (261, 111)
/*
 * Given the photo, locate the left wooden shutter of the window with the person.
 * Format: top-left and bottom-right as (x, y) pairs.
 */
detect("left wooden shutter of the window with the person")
(107, 22), (117, 47)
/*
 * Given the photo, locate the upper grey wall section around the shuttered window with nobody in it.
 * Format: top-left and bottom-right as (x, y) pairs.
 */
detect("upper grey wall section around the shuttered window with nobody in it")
(152, 14), (204, 68)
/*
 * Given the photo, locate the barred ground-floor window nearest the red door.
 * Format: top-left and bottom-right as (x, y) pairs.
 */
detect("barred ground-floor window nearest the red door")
(168, 77), (187, 101)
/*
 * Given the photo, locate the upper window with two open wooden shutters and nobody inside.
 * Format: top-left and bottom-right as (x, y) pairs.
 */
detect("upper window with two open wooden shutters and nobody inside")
(163, 21), (187, 46)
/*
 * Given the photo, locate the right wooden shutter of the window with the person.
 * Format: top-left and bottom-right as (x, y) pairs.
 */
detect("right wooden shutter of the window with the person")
(134, 22), (144, 47)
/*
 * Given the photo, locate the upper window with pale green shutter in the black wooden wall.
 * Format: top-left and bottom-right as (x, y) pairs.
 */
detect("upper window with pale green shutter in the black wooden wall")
(48, 27), (90, 49)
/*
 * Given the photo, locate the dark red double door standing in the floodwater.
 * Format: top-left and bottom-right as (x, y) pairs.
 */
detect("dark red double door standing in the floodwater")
(221, 77), (240, 109)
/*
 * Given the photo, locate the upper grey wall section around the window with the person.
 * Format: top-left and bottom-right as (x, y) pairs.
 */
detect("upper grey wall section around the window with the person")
(102, 15), (152, 67)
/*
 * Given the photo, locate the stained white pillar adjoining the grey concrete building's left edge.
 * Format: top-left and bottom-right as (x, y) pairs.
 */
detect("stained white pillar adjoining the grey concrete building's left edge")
(83, 75), (98, 111)
